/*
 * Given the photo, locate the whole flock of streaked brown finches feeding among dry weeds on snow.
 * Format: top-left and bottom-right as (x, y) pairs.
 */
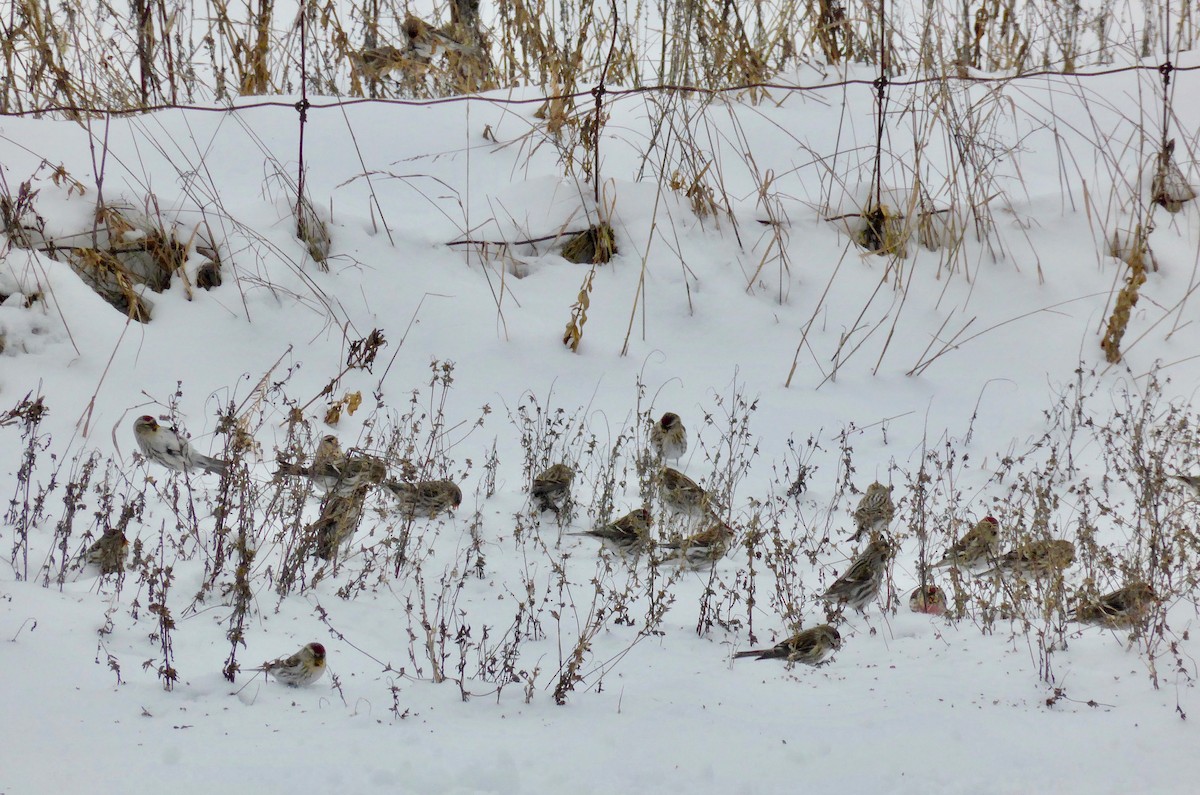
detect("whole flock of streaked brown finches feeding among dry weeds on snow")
(75, 412), (1200, 686)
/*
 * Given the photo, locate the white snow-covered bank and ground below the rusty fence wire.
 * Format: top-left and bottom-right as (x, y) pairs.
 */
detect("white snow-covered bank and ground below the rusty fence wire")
(0, 54), (1200, 794)
